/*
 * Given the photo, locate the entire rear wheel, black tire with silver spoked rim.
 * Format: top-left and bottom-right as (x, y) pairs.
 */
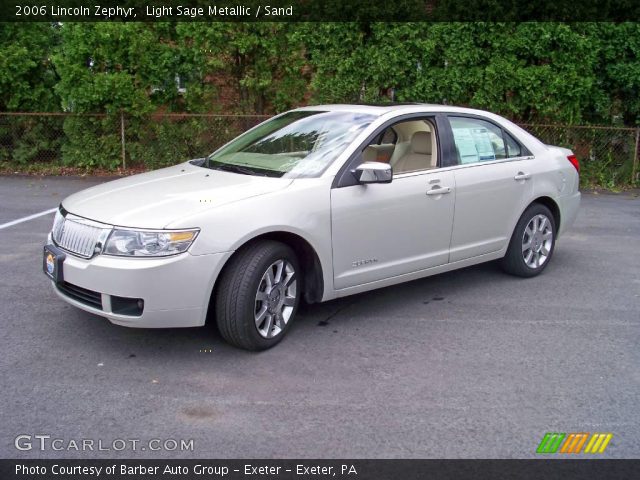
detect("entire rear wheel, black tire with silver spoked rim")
(501, 203), (556, 277)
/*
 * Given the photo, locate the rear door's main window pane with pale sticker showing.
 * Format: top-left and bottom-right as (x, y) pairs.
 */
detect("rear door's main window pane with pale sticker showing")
(449, 117), (507, 165)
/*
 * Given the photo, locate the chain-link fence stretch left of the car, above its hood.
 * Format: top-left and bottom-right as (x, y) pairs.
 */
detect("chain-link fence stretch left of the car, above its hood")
(0, 113), (269, 170)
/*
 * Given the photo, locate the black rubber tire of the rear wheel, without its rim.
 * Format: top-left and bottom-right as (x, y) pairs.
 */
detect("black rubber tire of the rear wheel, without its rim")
(500, 203), (556, 277)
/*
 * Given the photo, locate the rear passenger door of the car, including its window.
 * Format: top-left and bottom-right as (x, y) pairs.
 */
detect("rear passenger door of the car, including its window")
(448, 115), (534, 262)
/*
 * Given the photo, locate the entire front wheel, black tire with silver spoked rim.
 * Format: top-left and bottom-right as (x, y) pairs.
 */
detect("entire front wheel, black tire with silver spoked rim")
(214, 241), (302, 350)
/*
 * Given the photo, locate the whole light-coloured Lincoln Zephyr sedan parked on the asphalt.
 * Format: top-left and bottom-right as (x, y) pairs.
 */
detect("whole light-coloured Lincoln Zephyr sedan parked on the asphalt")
(43, 105), (580, 350)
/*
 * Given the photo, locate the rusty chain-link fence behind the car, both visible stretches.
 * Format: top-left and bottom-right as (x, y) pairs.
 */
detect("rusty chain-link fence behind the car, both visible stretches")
(0, 113), (640, 188)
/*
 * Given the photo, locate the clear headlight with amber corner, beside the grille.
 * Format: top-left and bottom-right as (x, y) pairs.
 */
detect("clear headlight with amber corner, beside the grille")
(102, 228), (198, 257)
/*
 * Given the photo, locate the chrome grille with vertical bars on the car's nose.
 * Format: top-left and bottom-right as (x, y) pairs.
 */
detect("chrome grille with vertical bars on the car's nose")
(52, 212), (104, 258)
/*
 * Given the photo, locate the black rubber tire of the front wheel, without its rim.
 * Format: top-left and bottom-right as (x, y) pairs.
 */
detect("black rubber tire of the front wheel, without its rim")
(214, 240), (302, 351)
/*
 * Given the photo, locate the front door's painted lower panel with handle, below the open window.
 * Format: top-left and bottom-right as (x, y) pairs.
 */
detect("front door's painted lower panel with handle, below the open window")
(331, 168), (455, 289)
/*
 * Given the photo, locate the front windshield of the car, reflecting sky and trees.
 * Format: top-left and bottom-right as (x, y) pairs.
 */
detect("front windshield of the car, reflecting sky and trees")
(203, 110), (375, 178)
